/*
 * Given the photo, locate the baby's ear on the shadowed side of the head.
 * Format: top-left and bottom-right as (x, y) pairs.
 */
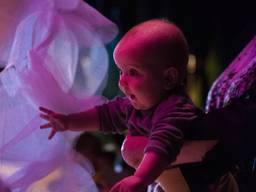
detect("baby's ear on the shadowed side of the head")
(164, 67), (178, 90)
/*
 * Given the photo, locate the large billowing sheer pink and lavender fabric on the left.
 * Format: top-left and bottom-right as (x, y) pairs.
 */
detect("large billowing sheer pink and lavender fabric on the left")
(0, 0), (117, 192)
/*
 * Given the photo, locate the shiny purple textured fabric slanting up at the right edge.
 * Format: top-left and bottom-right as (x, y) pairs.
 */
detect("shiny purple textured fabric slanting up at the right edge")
(206, 36), (256, 112)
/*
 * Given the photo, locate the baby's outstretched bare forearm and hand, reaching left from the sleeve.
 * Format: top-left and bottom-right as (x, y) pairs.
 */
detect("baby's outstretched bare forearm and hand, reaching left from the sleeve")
(39, 107), (99, 139)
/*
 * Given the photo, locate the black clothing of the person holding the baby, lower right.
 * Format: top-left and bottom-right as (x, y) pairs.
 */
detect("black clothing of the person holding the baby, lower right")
(191, 98), (256, 192)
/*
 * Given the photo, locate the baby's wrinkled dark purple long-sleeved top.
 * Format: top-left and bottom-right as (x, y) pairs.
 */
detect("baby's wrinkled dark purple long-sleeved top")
(97, 94), (202, 162)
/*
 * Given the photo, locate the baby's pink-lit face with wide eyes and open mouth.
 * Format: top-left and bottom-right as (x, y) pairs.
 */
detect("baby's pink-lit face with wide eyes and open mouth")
(114, 44), (166, 110)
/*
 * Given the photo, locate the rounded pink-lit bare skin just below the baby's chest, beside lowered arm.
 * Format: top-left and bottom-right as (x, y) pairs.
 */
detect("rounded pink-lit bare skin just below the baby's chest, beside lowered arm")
(121, 136), (148, 168)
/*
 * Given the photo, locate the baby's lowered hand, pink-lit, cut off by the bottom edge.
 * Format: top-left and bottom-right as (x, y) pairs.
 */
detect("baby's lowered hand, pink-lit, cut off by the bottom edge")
(110, 175), (147, 192)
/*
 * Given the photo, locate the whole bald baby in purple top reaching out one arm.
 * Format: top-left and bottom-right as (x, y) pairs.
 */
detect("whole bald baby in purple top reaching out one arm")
(40, 19), (201, 192)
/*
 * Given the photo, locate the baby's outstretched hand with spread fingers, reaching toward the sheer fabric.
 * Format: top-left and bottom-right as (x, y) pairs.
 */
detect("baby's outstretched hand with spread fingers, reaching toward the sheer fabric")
(39, 107), (68, 139)
